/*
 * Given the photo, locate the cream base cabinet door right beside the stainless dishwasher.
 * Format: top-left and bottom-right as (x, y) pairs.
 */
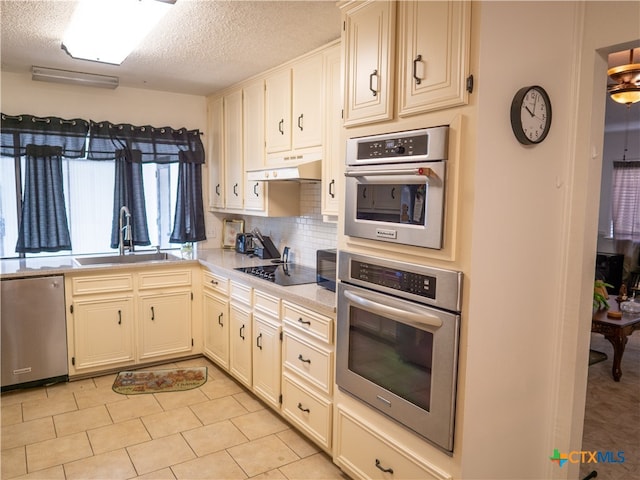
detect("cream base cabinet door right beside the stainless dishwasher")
(73, 295), (135, 371)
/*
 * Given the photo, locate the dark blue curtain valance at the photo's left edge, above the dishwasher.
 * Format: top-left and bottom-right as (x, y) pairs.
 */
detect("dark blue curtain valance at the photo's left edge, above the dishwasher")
(0, 114), (89, 158)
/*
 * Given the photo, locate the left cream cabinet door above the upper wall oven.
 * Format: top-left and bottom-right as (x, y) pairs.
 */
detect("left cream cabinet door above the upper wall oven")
(342, 1), (396, 127)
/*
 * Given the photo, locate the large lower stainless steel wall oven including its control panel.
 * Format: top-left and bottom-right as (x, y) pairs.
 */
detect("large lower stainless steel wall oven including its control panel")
(336, 251), (462, 453)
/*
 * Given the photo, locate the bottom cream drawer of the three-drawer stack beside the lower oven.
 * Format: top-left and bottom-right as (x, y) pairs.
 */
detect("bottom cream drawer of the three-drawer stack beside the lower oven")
(282, 373), (332, 450)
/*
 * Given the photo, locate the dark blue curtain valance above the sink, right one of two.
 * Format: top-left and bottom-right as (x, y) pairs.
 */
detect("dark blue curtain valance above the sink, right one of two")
(87, 121), (204, 163)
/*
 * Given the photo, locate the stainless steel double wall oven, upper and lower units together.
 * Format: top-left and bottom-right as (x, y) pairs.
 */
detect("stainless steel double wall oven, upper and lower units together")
(336, 126), (463, 454)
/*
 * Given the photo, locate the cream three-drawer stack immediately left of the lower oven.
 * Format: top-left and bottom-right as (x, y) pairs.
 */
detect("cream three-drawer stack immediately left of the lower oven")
(282, 300), (334, 452)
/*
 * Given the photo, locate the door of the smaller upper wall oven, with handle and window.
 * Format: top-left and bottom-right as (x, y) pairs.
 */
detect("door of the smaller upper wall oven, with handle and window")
(345, 162), (445, 248)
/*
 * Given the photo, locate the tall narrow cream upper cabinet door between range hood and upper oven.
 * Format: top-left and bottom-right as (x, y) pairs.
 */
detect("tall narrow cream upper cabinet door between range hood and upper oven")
(321, 46), (344, 217)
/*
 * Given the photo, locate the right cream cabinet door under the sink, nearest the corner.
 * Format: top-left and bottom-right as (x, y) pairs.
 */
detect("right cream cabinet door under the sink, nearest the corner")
(139, 291), (192, 360)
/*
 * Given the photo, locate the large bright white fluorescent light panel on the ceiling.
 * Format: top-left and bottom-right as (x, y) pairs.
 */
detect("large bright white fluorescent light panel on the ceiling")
(62, 0), (175, 65)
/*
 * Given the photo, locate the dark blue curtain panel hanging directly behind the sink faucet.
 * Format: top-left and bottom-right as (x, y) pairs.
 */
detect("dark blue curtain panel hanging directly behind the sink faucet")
(111, 151), (151, 248)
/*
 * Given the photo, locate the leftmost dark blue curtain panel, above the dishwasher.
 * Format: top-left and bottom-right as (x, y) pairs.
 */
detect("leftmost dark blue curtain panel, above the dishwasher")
(16, 145), (71, 253)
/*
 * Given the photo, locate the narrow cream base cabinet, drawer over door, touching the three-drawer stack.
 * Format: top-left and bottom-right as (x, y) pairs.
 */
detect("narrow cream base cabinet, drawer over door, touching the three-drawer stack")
(253, 289), (282, 410)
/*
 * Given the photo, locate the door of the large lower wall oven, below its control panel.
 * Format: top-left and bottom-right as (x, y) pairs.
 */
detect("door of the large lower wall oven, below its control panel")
(336, 282), (460, 451)
